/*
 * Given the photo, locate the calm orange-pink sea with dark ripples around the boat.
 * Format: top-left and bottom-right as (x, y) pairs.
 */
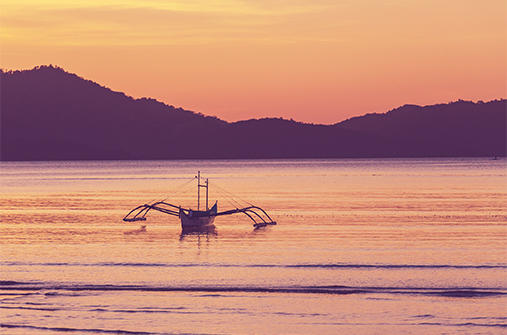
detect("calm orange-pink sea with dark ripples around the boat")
(0, 158), (507, 334)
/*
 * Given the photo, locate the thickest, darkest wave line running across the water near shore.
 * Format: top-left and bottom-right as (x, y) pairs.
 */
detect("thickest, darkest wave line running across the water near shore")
(0, 282), (507, 298)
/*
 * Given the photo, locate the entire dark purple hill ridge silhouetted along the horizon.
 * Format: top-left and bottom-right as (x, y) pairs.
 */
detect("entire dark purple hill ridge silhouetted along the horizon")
(0, 66), (507, 161)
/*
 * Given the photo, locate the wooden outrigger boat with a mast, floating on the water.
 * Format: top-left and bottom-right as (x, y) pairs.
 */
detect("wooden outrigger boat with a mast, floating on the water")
(123, 171), (276, 229)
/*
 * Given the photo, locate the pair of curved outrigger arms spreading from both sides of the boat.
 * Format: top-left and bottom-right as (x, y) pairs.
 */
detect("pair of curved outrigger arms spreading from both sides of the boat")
(123, 201), (276, 228)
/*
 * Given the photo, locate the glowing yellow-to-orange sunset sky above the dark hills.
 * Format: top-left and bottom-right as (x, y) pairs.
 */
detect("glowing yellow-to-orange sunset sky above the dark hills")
(0, 0), (507, 124)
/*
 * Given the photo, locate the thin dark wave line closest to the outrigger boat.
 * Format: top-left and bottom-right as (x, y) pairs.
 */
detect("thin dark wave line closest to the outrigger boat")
(0, 262), (507, 270)
